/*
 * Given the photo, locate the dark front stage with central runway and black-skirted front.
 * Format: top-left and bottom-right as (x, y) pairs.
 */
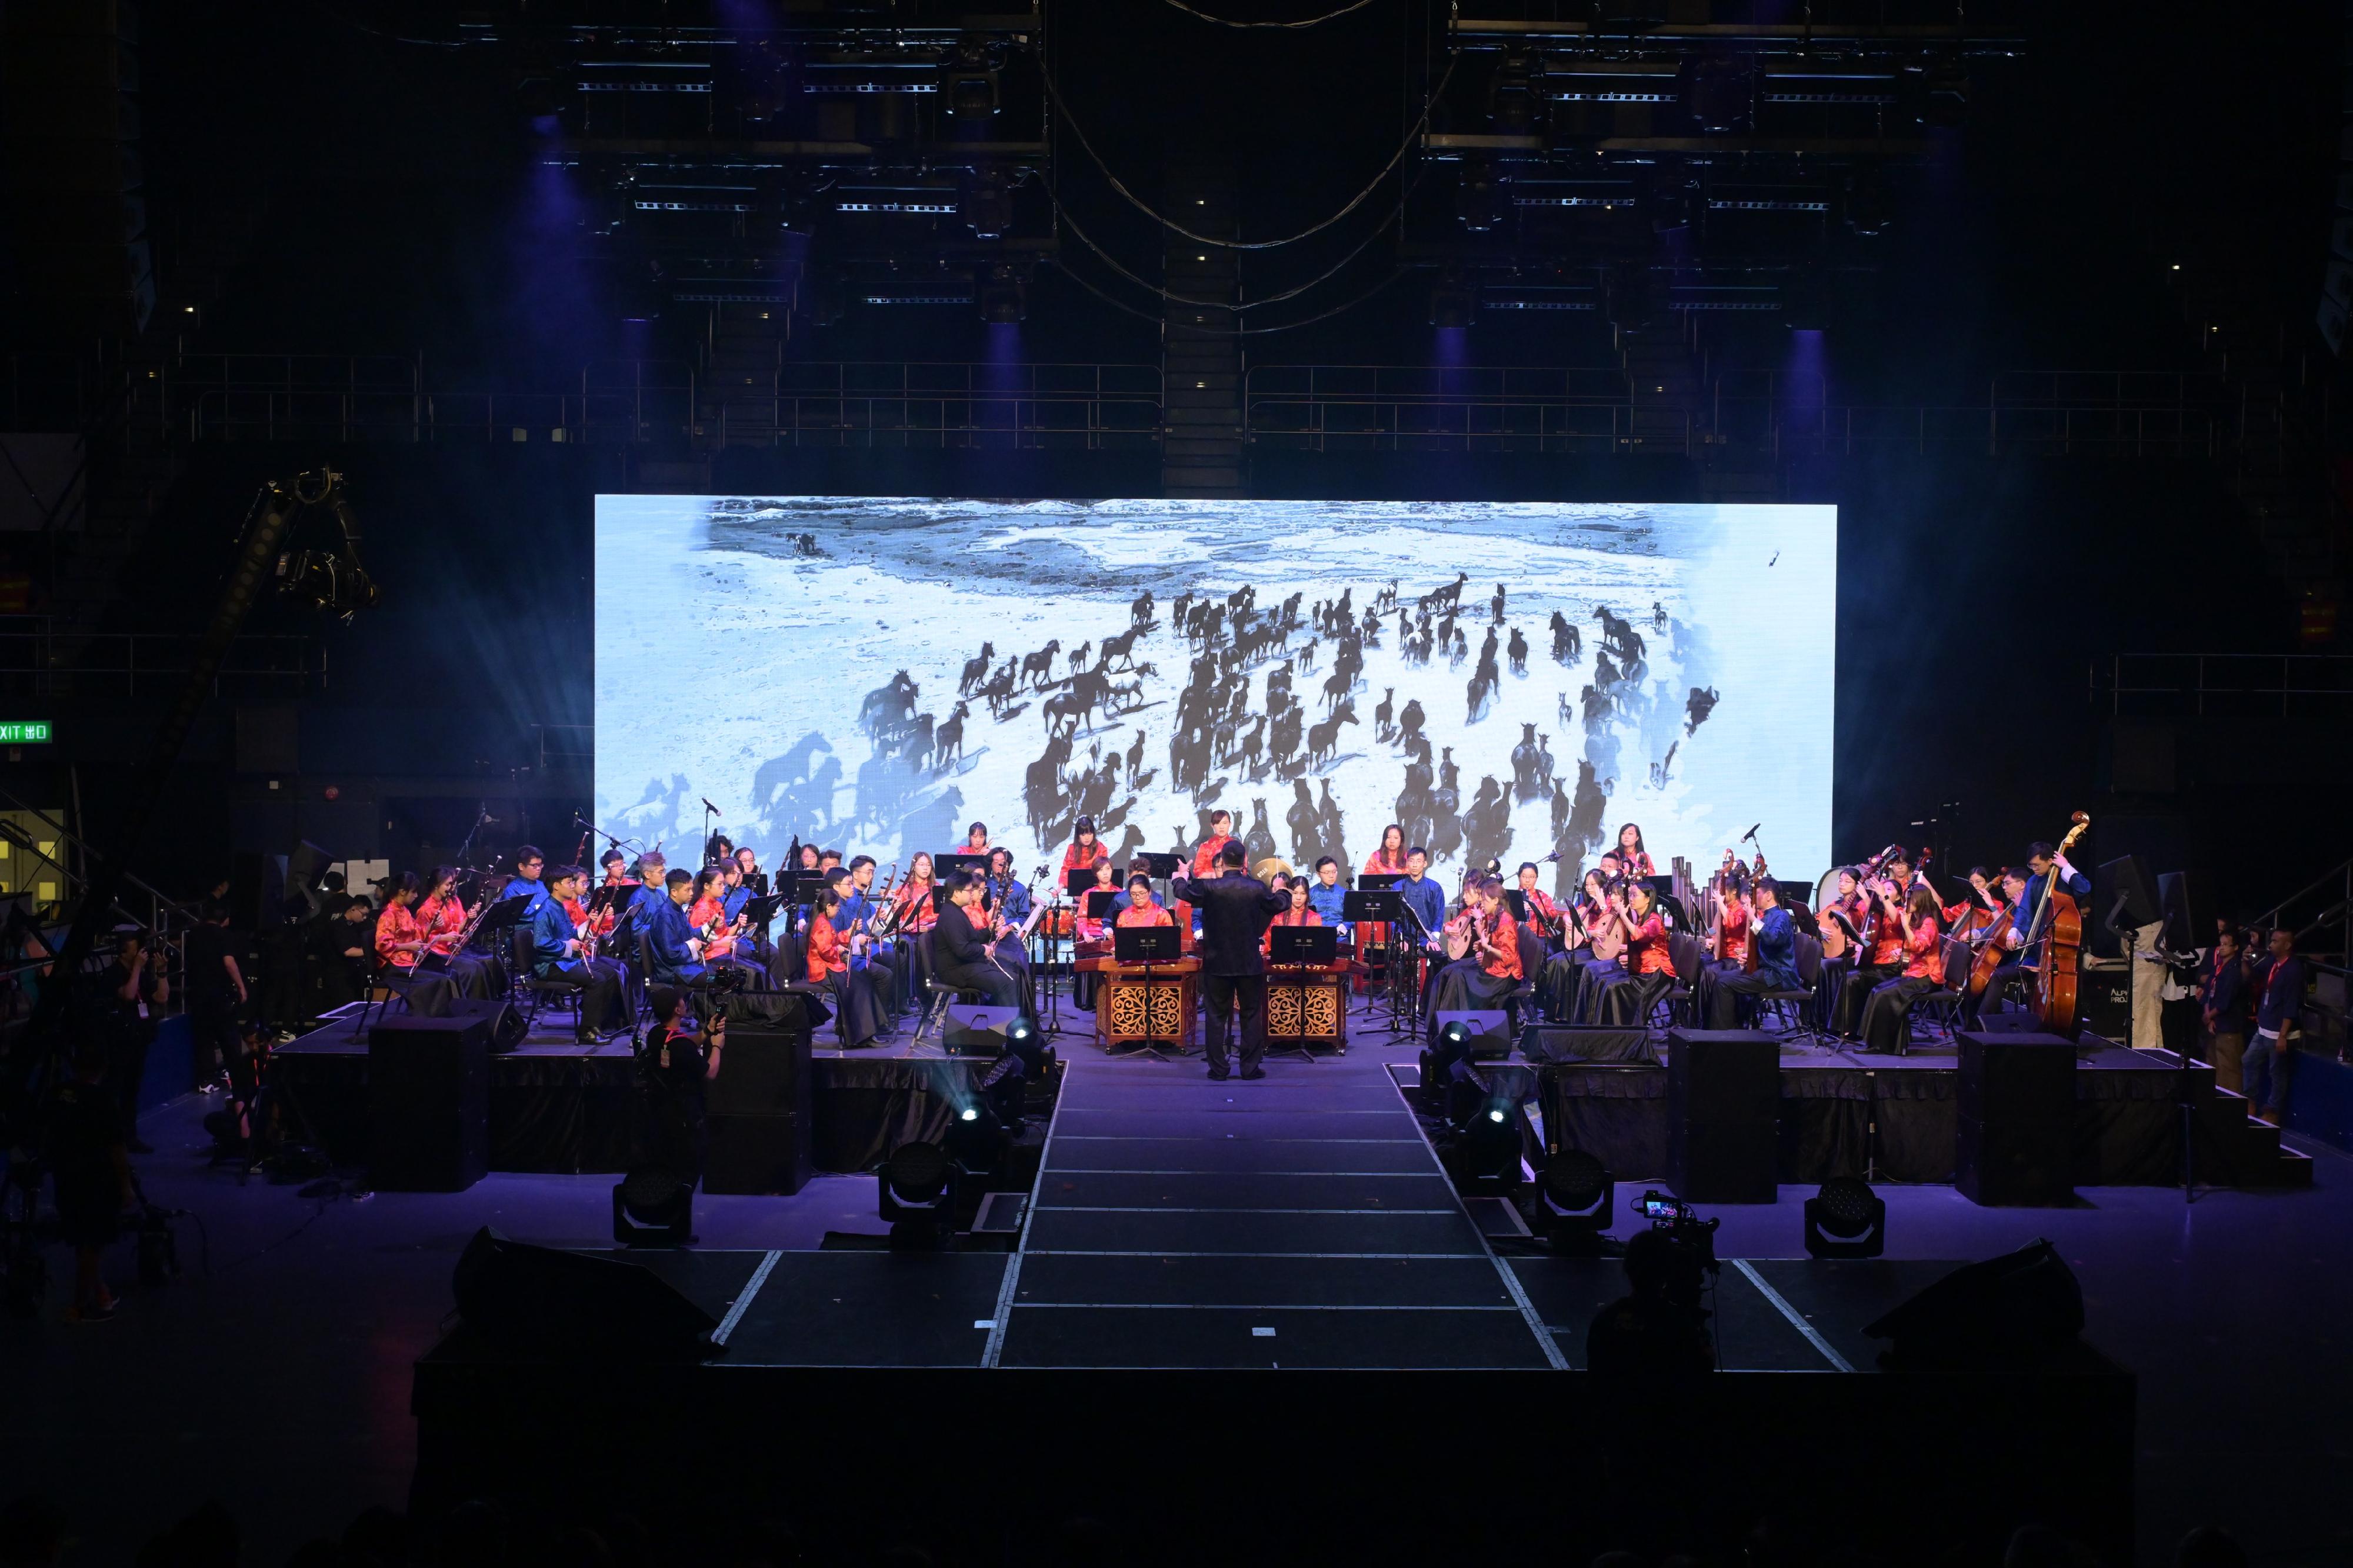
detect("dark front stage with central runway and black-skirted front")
(412, 1031), (2134, 1561)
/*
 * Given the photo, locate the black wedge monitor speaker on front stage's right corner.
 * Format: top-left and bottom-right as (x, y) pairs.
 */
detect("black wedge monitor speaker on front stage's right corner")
(1864, 1241), (2082, 1370)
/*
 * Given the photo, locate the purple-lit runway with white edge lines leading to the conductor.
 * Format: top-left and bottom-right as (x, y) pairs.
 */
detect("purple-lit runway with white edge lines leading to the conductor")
(986, 1022), (1562, 1368)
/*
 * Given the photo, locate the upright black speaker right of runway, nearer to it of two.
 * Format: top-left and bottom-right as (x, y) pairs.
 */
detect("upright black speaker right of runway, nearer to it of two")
(1666, 1029), (1781, 1203)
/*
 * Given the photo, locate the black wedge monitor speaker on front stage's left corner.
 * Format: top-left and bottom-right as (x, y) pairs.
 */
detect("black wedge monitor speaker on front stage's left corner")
(449, 1225), (720, 1361)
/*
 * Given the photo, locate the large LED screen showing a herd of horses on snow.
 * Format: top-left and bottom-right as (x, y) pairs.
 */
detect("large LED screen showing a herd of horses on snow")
(595, 495), (1838, 890)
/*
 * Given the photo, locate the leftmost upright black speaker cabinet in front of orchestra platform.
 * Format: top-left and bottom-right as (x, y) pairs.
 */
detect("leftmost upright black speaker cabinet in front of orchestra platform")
(367, 1015), (489, 1192)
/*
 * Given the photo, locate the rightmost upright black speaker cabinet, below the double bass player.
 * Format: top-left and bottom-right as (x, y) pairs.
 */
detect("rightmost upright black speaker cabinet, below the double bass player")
(1953, 1031), (2075, 1206)
